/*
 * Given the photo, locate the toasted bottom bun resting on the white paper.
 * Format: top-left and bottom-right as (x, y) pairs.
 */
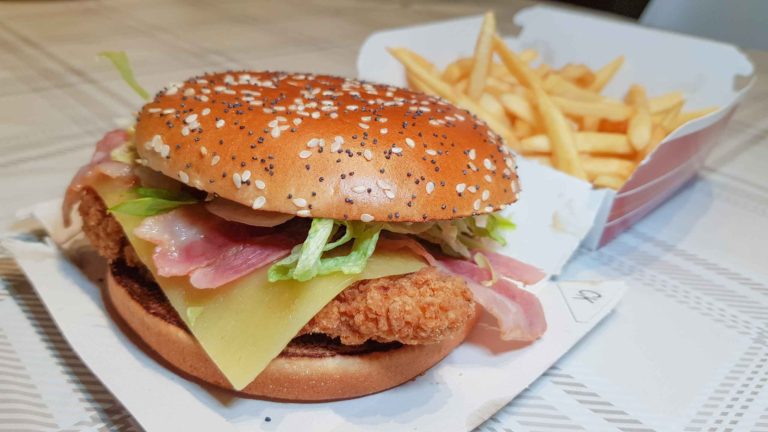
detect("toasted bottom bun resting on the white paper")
(106, 264), (478, 401)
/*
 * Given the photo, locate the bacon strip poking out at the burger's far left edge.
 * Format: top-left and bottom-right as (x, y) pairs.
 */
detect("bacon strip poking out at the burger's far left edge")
(61, 129), (133, 226)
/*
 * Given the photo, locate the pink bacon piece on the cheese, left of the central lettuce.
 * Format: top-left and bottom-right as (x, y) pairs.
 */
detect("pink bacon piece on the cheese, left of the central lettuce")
(134, 206), (297, 288)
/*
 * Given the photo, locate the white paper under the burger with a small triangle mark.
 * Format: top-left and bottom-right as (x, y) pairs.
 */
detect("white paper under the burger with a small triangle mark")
(3, 201), (625, 431)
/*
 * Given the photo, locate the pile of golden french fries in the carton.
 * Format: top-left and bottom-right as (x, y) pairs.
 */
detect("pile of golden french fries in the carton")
(389, 12), (716, 190)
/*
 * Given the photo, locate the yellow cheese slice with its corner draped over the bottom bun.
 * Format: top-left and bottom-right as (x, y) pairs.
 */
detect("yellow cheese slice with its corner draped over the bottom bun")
(95, 182), (426, 390)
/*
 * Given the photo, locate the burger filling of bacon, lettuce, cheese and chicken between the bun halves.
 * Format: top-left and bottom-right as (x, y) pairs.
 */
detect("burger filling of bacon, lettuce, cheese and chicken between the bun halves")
(64, 131), (546, 390)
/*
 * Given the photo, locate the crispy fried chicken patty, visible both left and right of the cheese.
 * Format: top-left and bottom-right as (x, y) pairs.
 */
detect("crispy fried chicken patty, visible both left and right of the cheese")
(79, 188), (475, 345)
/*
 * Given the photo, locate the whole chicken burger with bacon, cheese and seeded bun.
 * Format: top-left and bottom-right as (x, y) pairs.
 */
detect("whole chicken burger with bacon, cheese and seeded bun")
(63, 71), (546, 401)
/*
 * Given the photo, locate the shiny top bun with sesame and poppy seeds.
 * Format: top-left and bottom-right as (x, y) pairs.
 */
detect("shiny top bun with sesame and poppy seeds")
(136, 71), (519, 222)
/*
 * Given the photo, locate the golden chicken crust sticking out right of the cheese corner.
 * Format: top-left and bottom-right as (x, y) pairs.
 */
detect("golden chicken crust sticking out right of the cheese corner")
(300, 267), (475, 345)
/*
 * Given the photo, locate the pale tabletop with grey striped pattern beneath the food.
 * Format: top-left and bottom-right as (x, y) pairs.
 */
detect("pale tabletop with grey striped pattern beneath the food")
(0, 0), (768, 431)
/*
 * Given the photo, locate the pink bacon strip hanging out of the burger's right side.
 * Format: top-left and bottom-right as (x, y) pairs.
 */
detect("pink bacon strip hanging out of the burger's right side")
(377, 235), (547, 342)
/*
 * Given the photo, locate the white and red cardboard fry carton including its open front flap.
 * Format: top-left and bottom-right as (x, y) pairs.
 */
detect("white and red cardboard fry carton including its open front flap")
(357, 6), (754, 253)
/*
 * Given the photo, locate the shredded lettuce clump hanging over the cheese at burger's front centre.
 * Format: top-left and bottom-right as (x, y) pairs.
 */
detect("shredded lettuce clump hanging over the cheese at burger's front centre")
(268, 218), (382, 282)
